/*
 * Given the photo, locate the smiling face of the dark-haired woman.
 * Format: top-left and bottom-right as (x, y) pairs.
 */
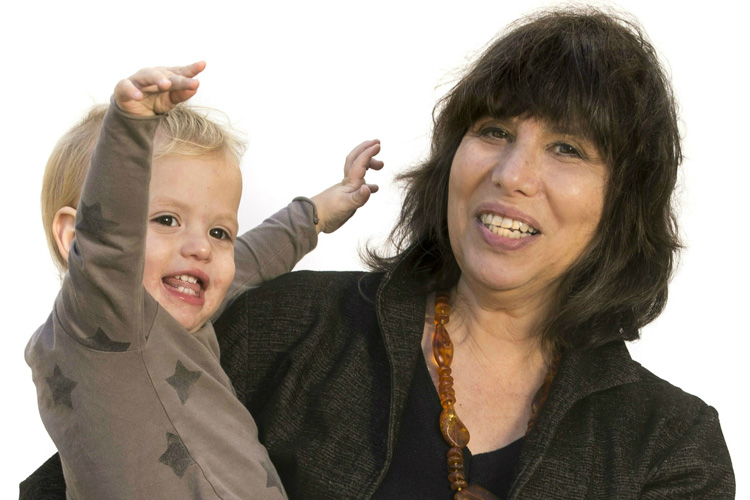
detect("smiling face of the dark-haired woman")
(448, 117), (608, 298)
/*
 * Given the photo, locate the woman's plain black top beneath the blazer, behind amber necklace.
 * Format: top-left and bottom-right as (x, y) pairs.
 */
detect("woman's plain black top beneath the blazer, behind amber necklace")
(373, 363), (523, 500)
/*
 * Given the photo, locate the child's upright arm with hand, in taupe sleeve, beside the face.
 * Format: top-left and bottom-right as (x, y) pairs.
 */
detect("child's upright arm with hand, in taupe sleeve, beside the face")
(60, 62), (205, 349)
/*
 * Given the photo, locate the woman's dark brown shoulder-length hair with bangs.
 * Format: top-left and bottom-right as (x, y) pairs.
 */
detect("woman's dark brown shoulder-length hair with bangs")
(369, 8), (682, 352)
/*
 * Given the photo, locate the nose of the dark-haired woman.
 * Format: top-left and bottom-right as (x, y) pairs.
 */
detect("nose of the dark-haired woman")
(491, 141), (541, 196)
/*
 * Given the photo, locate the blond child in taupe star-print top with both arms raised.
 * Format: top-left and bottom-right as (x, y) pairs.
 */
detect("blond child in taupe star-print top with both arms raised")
(26, 62), (382, 500)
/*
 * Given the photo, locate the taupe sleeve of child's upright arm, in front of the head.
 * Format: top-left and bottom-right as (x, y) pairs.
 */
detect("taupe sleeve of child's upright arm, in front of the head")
(55, 103), (160, 351)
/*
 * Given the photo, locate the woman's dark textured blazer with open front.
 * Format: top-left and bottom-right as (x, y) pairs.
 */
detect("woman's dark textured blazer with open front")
(21, 268), (735, 500)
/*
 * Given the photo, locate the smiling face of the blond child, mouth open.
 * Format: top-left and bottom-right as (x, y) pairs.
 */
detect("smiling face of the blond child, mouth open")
(143, 155), (242, 333)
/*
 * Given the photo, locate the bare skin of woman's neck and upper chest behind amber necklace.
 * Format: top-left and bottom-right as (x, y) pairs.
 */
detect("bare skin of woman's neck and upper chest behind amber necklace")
(422, 286), (548, 453)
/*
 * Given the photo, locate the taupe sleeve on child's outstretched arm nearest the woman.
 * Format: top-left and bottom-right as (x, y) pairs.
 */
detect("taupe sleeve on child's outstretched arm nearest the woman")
(219, 197), (318, 319)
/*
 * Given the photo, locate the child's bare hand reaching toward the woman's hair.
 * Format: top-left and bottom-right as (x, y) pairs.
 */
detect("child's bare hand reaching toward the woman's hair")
(312, 139), (383, 233)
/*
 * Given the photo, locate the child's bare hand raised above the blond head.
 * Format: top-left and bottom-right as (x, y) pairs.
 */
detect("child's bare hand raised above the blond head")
(114, 61), (206, 116)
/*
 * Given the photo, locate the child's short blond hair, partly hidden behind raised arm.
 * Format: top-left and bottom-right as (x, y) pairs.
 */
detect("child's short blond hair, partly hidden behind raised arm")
(41, 104), (245, 274)
